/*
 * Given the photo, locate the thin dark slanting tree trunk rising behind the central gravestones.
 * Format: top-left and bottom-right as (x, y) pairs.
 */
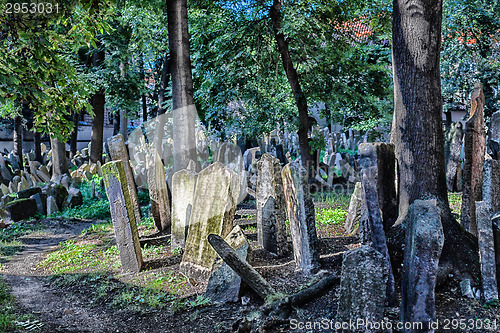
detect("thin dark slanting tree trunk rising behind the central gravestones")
(269, 0), (314, 176)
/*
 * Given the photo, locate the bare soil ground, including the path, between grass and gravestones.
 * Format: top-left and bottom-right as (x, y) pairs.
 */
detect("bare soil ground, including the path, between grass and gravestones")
(0, 201), (500, 333)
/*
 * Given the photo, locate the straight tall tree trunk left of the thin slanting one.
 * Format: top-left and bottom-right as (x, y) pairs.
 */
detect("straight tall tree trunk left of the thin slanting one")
(167, 0), (197, 172)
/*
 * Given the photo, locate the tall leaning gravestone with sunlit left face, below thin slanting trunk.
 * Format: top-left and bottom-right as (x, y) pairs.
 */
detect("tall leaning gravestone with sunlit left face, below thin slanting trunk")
(281, 162), (320, 275)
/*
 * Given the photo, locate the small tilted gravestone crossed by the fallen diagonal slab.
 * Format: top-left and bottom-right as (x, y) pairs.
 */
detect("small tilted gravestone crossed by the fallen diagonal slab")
(206, 226), (251, 303)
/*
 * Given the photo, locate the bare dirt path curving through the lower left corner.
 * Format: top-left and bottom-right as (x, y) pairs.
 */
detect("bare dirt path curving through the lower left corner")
(1, 222), (129, 332)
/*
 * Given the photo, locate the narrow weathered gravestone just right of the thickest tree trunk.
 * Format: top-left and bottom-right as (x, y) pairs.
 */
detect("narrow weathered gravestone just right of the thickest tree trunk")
(445, 121), (464, 192)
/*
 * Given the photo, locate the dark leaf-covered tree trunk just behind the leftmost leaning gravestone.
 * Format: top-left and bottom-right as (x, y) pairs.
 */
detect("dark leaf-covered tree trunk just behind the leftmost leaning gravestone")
(90, 50), (106, 163)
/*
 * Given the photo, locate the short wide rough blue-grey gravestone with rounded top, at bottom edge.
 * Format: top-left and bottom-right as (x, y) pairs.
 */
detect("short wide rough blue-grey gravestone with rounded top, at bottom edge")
(336, 245), (390, 332)
